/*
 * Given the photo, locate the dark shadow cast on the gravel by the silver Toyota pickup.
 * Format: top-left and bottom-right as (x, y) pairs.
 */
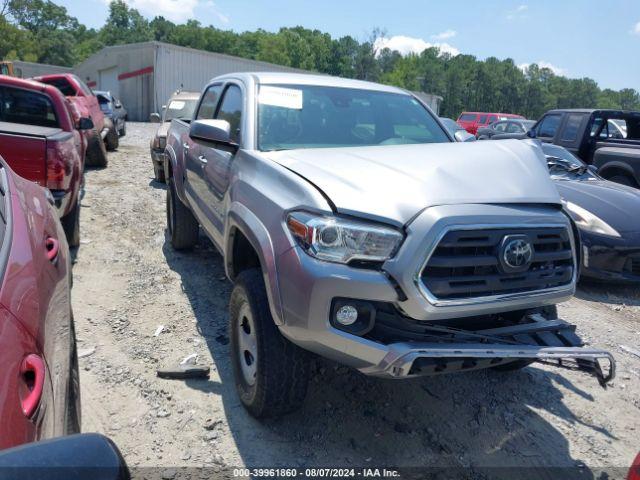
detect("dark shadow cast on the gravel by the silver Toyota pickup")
(163, 232), (613, 479)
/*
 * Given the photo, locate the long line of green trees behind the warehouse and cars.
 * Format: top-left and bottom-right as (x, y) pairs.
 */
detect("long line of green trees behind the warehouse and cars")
(0, 0), (640, 119)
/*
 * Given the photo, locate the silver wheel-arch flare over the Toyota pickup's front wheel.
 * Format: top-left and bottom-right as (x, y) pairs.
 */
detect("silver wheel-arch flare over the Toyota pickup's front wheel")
(224, 202), (284, 325)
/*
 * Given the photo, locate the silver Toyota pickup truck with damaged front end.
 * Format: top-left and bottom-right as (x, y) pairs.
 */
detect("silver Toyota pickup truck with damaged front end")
(165, 73), (614, 417)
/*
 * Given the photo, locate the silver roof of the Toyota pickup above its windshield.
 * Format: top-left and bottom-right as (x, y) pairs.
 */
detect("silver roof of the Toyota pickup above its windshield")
(215, 72), (409, 95)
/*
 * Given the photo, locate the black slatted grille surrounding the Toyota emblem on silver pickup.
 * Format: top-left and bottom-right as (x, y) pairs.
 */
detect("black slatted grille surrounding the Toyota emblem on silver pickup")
(420, 227), (574, 300)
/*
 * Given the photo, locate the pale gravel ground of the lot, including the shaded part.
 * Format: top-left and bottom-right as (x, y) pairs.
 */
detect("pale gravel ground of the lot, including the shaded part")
(73, 123), (640, 478)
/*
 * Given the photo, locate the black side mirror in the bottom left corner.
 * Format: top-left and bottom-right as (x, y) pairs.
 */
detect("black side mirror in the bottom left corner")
(0, 433), (130, 480)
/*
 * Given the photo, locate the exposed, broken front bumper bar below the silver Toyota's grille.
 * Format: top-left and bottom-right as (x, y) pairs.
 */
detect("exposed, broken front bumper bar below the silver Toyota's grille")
(361, 314), (616, 387)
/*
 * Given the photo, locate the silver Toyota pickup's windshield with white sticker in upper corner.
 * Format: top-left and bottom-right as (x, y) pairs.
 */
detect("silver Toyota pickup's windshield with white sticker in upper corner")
(258, 85), (451, 151)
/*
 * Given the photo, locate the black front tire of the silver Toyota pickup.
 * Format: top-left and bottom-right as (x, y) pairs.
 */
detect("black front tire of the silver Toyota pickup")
(229, 268), (310, 418)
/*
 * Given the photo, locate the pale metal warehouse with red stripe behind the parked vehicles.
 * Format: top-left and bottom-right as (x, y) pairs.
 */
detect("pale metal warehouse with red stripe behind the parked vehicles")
(74, 42), (442, 121)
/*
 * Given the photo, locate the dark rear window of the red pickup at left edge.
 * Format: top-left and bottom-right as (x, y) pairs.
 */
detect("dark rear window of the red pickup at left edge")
(0, 87), (58, 127)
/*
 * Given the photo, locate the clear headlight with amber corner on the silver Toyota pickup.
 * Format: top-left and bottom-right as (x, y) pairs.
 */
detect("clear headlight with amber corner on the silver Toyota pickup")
(287, 212), (403, 263)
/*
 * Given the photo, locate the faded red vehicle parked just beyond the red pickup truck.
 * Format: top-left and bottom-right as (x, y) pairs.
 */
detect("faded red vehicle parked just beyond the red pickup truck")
(34, 73), (109, 167)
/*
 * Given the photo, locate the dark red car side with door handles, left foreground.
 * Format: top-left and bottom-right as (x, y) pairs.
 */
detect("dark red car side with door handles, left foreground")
(0, 158), (80, 449)
